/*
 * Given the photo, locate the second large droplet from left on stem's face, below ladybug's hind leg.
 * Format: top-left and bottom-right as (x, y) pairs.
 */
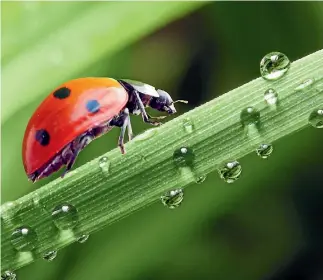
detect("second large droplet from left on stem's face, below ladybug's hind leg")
(52, 203), (78, 230)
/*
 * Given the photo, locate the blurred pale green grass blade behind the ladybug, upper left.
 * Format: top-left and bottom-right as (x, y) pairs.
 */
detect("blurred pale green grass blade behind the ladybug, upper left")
(1, 2), (205, 124)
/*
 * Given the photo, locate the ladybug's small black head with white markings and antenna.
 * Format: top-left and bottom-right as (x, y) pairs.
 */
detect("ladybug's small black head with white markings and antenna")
(149, 89), (187, 114)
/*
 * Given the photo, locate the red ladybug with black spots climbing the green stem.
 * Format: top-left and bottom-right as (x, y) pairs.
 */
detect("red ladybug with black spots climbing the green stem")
(22, 77), (187, 182)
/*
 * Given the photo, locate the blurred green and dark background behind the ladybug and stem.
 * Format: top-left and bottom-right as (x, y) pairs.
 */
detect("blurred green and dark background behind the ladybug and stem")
(1, 1), (323, 280)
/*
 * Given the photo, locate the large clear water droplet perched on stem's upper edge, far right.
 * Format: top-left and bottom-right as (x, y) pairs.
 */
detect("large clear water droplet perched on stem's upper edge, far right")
(260, 52), (290, 80)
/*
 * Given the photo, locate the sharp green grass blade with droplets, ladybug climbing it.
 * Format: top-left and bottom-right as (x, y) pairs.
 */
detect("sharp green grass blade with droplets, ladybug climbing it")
(1, 50), (323, 271)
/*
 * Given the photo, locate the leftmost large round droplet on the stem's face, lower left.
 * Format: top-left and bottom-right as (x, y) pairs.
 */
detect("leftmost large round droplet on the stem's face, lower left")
(11, 226), (38, 252)
